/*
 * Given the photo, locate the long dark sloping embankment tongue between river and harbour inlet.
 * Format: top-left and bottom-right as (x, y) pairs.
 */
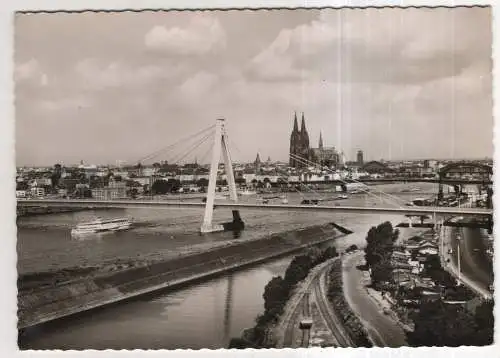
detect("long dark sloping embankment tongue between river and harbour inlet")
(18, 224), (350, 328)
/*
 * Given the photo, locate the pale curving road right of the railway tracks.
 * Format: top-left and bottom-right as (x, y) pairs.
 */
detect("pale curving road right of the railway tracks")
(343, 251), (407, 348)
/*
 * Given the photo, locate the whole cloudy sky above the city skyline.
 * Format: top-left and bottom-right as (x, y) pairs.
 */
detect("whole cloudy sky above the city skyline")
(14, 8), (493, 165)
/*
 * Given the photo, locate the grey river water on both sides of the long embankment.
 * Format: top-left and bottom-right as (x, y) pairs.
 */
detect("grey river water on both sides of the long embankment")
(17, 183), (437, 349)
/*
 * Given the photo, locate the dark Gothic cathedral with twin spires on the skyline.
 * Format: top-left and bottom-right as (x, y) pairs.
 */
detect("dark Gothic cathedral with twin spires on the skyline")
(290, 113), (340, 169)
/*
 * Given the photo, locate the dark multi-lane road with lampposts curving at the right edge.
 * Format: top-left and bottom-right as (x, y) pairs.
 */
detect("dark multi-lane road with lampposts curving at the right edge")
(442, 227), (493, 298)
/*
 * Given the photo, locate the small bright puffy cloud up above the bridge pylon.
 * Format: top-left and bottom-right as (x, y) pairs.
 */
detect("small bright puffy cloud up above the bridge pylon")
(144, 13), (226, 55)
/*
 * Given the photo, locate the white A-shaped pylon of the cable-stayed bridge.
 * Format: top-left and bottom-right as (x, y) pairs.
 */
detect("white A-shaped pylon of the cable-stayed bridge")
(200, 119), (244, 233)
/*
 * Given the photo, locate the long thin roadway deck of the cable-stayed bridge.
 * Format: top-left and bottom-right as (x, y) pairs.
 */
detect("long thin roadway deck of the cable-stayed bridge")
(17, 199), (493, 217)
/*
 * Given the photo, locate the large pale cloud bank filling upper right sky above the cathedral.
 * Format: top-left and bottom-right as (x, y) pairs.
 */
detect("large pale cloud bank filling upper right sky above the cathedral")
(249, 9), (491, 84)
